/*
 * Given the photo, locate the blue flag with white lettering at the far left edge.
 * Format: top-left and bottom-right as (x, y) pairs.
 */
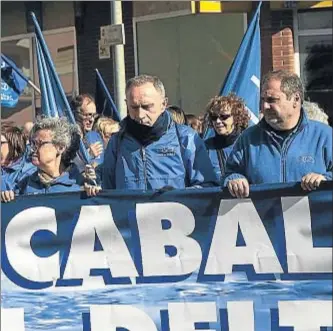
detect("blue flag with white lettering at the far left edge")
(1, 54), (28, 108)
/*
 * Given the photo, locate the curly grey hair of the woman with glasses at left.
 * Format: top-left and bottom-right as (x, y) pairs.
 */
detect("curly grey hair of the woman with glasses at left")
(30, 117), (80, 166)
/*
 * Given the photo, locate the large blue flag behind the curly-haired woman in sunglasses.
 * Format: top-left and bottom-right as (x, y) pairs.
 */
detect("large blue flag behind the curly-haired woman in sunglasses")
(220, 2), (261, 124)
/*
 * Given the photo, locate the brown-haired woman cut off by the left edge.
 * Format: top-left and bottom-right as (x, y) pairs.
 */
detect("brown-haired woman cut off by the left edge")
(1, 124), (35, 190)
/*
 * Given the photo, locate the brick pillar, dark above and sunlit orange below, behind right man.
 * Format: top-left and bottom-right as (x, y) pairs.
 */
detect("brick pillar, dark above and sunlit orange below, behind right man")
(260, 2), (295, 74)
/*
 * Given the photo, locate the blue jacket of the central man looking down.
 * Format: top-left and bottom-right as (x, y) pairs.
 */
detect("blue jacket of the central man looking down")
(102, 117), (217, 190)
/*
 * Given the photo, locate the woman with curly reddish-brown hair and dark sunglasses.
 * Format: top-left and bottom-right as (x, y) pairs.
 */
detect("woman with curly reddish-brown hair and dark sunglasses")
(205, 94), (250, 180)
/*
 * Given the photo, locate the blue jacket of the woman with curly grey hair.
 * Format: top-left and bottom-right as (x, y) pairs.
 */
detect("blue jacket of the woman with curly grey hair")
(15, 167), (80, 195)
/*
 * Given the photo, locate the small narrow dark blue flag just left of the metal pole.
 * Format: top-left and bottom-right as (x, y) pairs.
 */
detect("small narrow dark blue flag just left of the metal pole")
(95, 69), (121, 122)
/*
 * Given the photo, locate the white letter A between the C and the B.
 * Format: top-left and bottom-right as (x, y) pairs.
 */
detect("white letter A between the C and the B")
(64, 205), (138, 283)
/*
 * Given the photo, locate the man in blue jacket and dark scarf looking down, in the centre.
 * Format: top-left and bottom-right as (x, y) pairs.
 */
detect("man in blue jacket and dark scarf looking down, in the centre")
(88, 75), (217, 195)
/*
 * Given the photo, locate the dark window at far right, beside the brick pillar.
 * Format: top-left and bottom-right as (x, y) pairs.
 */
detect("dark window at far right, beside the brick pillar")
(295, 8), (333, 119)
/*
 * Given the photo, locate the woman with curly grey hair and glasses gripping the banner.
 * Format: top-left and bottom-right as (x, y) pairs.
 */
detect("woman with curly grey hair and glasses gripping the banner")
(1, 118), (81, 202)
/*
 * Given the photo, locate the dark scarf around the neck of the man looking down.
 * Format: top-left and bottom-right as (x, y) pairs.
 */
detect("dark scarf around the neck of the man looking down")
(125, 111), (169, 146)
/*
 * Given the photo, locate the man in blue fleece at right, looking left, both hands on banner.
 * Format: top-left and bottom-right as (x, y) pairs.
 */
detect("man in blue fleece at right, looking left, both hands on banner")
(224, 70), (332, 198)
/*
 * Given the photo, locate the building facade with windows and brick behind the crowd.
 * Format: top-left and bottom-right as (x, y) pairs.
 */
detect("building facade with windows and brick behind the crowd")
(1, 1), (333, 125)
